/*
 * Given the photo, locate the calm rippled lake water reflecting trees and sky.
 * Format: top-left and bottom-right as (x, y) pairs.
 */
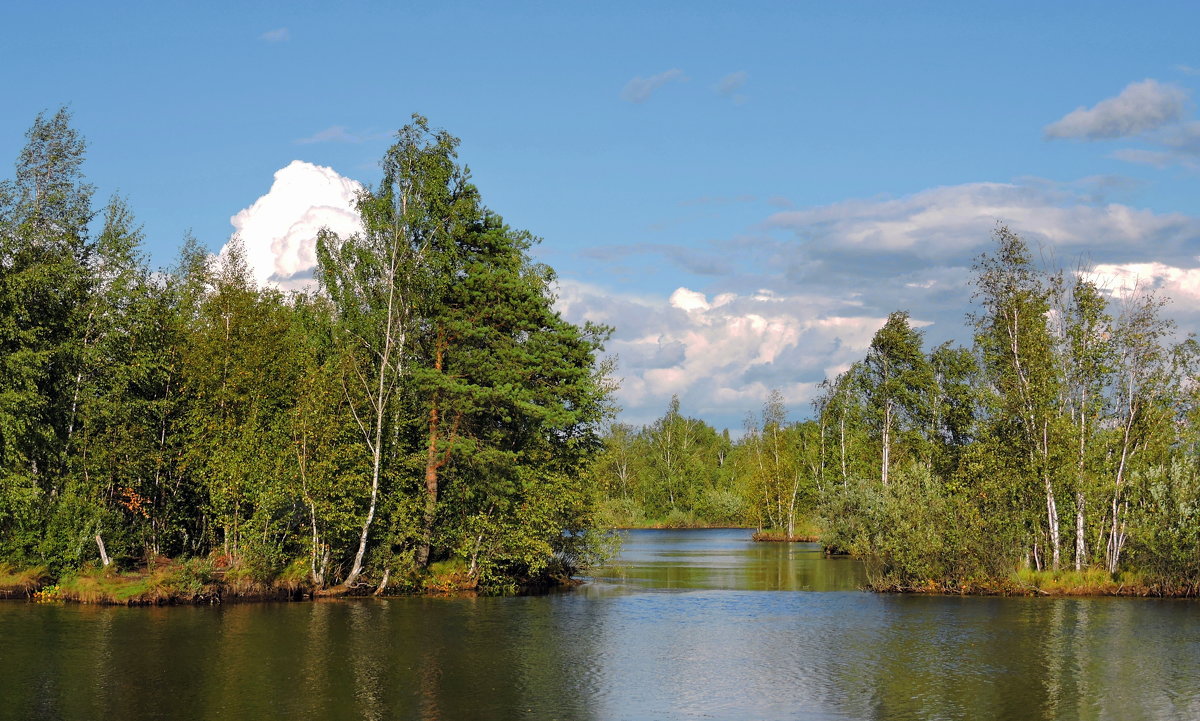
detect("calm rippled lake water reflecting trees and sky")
(0, 530), (1200, 720)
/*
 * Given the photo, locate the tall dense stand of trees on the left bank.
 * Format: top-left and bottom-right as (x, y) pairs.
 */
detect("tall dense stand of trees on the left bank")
(0, 110), (610, 589)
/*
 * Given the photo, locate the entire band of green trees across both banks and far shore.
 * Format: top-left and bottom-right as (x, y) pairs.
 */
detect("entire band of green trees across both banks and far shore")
(0, 110), (1200, 602)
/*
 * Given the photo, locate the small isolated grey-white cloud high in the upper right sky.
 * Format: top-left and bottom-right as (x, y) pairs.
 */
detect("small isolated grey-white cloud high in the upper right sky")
(1045, 79), (1188, 140)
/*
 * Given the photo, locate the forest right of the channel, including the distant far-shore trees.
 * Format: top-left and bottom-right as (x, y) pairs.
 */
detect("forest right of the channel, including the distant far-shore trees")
(598, 227), (1200, 595)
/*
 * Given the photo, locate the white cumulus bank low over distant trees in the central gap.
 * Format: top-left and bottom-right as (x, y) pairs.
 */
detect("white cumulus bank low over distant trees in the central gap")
(558, 278), (886, 429)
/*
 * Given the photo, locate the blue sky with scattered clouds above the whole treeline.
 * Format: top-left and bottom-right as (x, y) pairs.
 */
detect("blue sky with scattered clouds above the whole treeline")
(0, 2), (1200, 427)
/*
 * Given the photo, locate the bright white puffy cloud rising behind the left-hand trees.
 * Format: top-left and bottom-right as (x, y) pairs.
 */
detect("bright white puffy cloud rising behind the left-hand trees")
(222, 161), (362, 289)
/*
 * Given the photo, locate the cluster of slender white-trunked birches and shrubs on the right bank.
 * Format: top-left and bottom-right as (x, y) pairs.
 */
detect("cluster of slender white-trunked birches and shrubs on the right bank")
(816, 228), (1200, 594)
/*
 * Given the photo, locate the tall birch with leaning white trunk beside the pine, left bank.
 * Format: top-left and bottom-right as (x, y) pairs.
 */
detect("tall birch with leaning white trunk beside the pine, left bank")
(317, 115), (464, 587)
